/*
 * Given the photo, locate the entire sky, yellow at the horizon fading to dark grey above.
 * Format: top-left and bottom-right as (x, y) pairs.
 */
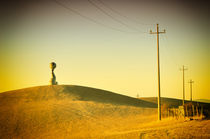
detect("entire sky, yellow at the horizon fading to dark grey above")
(0, 0), (210, 99)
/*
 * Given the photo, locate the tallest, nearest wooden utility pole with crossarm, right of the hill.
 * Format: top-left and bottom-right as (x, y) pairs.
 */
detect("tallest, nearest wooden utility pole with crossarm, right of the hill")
(150, 24), (166, 121)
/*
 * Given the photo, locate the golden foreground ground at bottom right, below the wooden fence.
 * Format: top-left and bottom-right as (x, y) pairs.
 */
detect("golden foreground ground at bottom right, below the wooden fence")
(105, 120), (210, 139)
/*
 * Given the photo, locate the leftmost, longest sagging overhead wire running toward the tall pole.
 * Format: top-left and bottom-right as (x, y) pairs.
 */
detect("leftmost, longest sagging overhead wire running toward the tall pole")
(52, 0), (143, 34)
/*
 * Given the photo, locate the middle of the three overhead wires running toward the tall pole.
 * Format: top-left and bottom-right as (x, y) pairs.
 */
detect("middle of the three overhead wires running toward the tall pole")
(87, 0), (145, 33)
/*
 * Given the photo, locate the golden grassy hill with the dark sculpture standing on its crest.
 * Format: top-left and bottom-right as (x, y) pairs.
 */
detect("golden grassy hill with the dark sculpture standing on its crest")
(0, 85), (157, 138)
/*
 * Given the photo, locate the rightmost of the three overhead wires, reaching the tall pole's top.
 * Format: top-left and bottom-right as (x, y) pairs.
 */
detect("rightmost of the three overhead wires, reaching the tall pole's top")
(97, 0), (154, 25)
